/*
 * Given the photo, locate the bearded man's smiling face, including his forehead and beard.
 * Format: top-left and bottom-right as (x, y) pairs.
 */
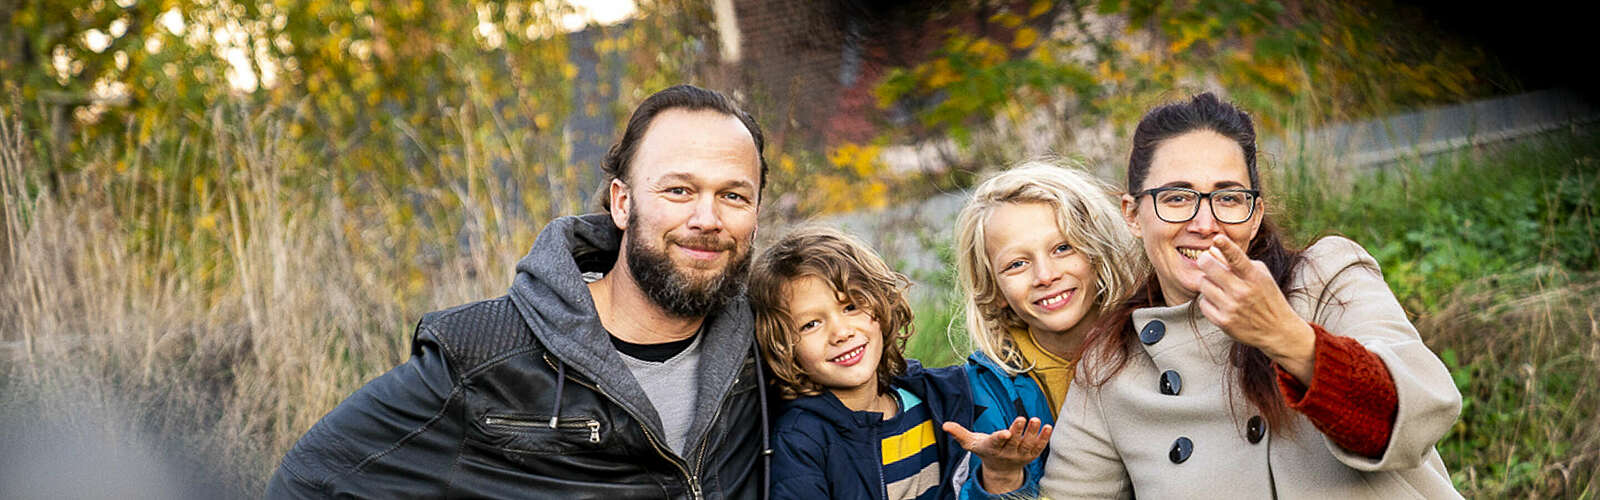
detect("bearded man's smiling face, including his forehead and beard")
(611, 109), (760, 317)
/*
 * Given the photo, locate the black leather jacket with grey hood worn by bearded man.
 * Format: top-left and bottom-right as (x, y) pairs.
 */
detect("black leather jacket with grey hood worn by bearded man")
(267, 216), (766, 498)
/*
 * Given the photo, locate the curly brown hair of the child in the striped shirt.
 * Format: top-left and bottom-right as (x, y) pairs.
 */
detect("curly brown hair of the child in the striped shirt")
(749, 228), (914, 399)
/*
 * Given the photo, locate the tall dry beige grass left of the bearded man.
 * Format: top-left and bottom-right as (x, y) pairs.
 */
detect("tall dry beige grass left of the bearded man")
(0, 102), (547, 495)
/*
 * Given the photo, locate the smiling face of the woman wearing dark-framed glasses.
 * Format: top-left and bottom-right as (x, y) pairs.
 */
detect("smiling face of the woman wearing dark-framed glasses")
(1122, 130), (1262, 304)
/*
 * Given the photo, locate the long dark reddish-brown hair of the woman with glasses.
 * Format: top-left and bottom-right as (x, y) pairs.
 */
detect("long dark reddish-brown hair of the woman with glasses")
(1080, 93), (1301, 428)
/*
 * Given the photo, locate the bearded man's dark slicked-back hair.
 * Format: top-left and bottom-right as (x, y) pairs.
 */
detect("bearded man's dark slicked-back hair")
(595, 85), (766, 212)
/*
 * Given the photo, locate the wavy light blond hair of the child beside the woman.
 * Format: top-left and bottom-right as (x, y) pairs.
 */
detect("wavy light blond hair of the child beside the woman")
(955, 160), (1149, 375)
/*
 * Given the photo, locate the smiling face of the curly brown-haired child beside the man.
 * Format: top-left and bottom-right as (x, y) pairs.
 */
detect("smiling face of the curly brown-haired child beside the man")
(784, 276), (883, 402)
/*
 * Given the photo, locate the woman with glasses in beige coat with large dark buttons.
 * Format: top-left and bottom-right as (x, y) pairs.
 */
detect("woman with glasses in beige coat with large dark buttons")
(1040, 93), (1461, 498)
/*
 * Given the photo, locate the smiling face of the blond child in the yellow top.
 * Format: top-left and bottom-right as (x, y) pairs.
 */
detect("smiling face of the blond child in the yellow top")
(984, 204), (1098, 338)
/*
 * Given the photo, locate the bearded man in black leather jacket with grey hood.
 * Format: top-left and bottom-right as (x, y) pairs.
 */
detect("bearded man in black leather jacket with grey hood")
(267, 85), (766, 498)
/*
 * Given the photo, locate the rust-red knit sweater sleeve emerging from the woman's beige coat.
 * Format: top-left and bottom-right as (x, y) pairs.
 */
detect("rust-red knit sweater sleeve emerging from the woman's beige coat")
(1277, 324), (1400, 458)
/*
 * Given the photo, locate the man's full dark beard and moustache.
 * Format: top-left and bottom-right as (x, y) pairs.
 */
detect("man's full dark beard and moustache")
(627, 212), (750, 317)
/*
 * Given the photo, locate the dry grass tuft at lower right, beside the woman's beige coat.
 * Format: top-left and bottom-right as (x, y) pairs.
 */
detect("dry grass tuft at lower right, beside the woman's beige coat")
(1418, 266), (1600, 498)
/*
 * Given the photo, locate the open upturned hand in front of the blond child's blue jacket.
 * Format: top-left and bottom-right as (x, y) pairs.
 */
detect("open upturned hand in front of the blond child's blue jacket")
(942, 417), (1054, 494)
